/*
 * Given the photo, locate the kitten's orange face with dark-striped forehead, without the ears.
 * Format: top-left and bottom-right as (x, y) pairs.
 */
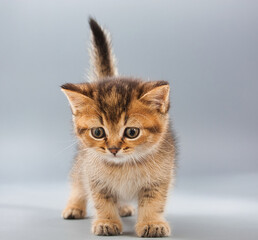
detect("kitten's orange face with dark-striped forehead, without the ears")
(61, 80), (168, 163)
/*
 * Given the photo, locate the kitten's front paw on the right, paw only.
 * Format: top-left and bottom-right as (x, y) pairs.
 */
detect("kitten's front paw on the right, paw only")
(135, 221), (170, 237)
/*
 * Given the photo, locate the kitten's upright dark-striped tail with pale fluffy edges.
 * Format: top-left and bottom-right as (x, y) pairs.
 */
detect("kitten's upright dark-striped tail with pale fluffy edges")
(89, 18), (117, 81)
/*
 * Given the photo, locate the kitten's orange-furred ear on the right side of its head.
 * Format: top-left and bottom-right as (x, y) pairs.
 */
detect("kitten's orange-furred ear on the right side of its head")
(140, 84), (169, 113)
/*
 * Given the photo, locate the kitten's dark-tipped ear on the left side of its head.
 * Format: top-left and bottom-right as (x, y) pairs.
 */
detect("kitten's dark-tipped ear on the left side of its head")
(61, 84), (94, 115)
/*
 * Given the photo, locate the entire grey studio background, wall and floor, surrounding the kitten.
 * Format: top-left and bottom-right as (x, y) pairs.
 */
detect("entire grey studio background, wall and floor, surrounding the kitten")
(0, 0), (258, 239)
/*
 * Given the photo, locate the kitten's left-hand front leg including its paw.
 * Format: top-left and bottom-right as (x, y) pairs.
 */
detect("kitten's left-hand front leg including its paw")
(92, 191), (122, 236)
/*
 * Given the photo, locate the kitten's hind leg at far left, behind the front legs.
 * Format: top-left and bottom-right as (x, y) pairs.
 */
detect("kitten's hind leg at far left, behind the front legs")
(62, 180), (87, 219)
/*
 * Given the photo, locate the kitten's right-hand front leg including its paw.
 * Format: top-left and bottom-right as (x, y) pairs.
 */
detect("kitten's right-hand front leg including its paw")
(135, 184), (170, 237)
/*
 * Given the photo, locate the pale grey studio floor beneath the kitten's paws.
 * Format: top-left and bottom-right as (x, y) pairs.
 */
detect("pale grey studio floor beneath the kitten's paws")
(0, 174), (258, 240)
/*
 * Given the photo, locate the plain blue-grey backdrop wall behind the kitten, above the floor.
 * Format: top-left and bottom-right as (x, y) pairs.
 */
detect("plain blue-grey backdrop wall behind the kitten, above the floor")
(0, 0), (258, 182)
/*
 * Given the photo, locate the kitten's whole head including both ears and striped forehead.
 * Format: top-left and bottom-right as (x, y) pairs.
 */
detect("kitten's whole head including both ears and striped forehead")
(62, 78), (169, 163)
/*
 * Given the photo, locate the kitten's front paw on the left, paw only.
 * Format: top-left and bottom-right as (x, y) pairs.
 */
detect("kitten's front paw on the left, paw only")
(92, 219), (122, 236)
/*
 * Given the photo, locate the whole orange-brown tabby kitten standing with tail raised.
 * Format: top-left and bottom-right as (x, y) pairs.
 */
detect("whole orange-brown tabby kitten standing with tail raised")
(62, 19), (175, 237)
